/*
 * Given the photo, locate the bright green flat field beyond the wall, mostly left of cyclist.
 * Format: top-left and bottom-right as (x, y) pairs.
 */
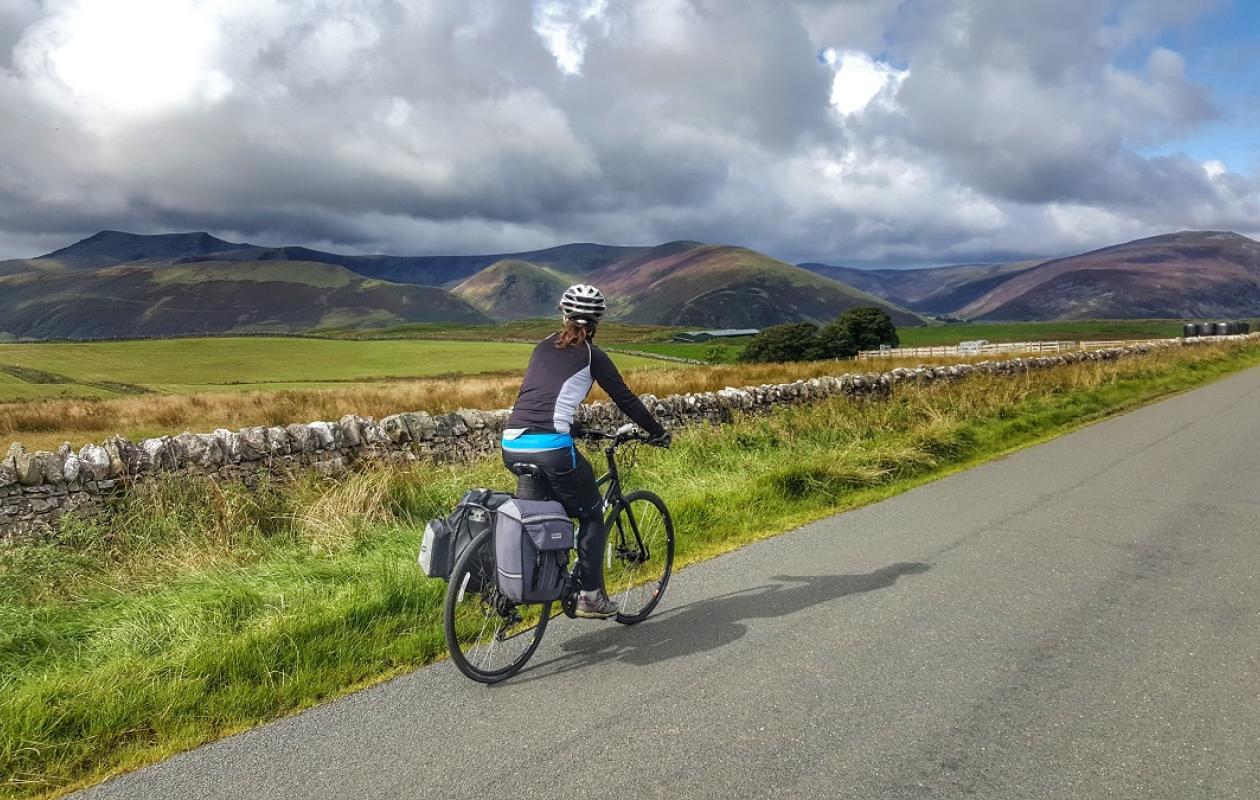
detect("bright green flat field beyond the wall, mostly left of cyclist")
(0, 336), (662, 402)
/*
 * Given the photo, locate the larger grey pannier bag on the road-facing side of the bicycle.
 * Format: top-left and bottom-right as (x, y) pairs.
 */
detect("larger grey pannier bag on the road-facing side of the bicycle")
(494, 500), (573, 602)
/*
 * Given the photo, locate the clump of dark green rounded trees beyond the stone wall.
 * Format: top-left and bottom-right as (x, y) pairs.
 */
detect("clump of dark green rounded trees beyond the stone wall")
(740, 306), (900, 362)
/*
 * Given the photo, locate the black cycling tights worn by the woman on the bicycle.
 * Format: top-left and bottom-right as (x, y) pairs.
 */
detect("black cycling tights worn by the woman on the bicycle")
(503, 449), (609, 590)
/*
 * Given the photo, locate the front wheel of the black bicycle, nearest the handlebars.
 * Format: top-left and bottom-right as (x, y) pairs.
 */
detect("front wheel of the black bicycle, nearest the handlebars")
(604, 491), (674, 625)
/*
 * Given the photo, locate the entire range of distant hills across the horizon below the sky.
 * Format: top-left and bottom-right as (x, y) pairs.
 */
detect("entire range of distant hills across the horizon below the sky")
(0, 231), (1260, 340)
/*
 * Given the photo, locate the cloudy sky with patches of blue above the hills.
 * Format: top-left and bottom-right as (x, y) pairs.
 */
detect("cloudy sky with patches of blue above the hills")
(0, 0), (1260, 266)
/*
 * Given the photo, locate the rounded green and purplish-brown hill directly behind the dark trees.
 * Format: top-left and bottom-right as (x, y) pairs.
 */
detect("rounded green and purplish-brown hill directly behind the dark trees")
(587, 242), (922, 328)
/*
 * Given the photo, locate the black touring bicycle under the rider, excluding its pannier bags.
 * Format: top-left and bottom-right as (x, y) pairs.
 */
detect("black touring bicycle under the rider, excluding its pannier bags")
(442, 425), (674, 683)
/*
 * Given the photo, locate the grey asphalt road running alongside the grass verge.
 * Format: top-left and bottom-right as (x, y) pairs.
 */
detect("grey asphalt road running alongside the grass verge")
(81, 369), (1260, 800)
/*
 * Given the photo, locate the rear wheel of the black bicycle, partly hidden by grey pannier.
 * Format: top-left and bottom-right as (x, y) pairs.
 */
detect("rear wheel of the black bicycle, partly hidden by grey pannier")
(442, 530), (551, 683)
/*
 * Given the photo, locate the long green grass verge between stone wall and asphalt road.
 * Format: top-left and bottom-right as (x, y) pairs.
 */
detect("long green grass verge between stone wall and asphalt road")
(0, 345), (1260, 797)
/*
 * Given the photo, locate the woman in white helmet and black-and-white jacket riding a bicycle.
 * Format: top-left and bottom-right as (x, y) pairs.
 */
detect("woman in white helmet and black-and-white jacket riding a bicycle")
(501, 283), (669, 619)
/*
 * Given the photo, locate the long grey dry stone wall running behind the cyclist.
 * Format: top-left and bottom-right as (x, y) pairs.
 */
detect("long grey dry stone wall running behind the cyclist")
(0, 334), (1260, 543)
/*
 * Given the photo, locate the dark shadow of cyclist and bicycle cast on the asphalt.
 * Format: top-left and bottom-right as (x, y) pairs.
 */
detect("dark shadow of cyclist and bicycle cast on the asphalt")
(513, 562), (931, 683)
